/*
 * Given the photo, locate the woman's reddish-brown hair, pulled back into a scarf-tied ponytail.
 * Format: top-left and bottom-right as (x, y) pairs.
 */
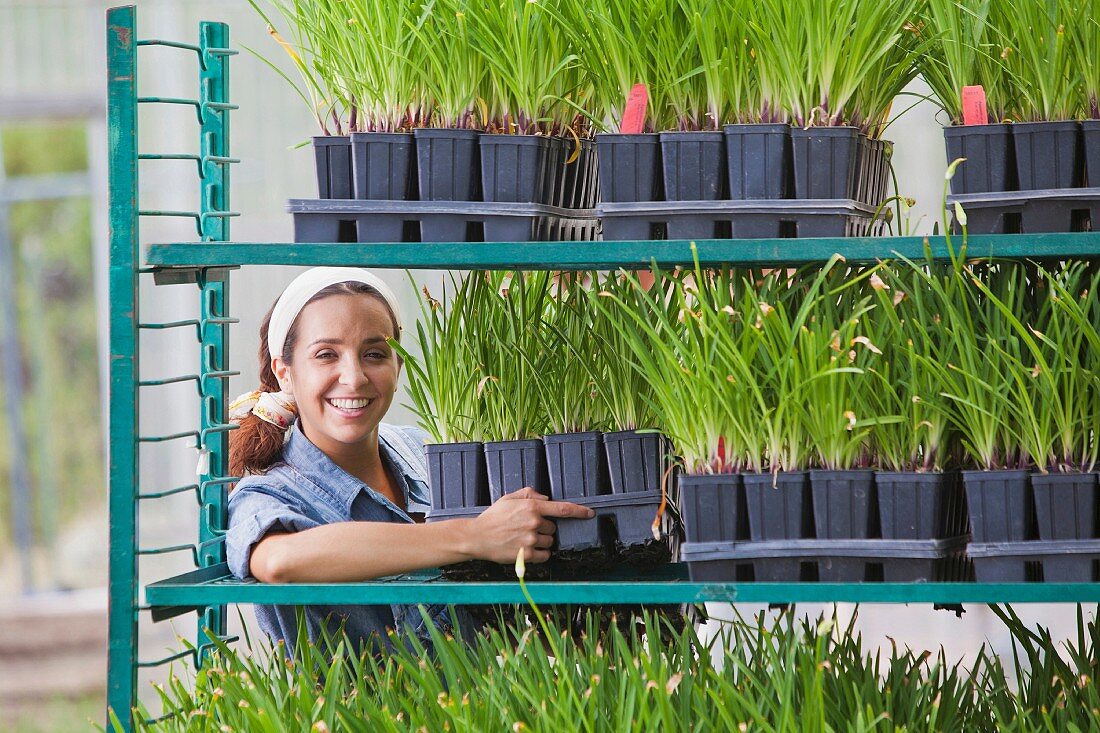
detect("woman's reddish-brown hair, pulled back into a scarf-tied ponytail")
(229, 277), (400, 477)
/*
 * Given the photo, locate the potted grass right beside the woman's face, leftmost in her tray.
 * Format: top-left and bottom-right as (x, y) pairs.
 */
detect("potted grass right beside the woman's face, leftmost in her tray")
(391, 270), (490, 518)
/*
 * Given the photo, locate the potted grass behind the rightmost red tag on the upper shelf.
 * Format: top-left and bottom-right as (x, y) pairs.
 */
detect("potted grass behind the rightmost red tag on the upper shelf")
(921, 0), (1016, 195)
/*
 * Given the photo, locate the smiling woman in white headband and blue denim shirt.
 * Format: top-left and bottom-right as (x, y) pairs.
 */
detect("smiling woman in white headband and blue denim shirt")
(227, 267), (592, 648)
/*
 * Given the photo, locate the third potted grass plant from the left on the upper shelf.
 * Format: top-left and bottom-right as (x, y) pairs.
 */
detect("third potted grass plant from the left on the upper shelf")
(409, 0), (487, 208)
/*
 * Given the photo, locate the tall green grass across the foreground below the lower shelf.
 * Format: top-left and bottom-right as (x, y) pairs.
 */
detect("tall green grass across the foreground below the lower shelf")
(117, 606), (1100, 733)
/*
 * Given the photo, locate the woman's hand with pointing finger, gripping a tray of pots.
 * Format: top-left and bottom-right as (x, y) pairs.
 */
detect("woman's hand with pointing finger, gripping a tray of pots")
(470, 486), (596, 564)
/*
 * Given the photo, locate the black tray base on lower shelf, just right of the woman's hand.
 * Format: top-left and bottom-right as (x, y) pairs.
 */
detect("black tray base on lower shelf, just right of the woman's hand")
(680, 535), (968, 582)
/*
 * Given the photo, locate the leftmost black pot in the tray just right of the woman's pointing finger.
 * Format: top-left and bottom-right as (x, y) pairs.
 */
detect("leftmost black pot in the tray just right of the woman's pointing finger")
(680, 473), (749, 543)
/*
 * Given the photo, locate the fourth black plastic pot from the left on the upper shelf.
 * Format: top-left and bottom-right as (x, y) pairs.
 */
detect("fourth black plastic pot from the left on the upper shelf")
(479, 134), (551, 204)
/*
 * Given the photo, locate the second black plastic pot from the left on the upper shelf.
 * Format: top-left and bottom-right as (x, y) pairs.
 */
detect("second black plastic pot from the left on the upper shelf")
(351, 132), (417, 201)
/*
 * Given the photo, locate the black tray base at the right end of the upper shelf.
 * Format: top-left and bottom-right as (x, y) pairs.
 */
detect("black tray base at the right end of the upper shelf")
(947, 187), (1100, 234)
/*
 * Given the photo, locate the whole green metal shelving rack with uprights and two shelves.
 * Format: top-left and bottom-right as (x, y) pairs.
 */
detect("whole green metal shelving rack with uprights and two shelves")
(107, 7), (1100, 723)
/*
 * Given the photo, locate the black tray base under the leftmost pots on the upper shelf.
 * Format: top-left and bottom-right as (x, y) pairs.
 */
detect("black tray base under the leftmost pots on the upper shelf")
(286, 198), (596, 243)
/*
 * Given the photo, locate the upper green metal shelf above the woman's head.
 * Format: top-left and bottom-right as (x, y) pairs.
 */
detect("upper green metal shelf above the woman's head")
(146, 232), (1100, 270)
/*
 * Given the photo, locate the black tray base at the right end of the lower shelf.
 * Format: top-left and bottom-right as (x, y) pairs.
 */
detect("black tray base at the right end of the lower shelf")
(967, 539), (1100, 583)
